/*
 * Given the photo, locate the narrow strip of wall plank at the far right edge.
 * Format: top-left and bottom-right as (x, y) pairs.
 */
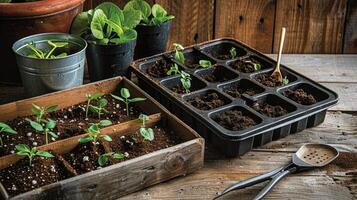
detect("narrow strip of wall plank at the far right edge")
(343, 0), (357, 53)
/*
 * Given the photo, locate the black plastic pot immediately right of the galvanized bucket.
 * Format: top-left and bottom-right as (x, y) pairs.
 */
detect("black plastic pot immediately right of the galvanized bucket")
(86, 40), (136, 82)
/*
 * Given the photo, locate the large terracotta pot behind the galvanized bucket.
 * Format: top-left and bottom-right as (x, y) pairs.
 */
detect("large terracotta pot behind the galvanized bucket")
(0, 0), (85, 85)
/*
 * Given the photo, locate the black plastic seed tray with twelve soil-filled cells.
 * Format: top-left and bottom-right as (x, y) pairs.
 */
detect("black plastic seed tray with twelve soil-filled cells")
(132, 39), (338, 157)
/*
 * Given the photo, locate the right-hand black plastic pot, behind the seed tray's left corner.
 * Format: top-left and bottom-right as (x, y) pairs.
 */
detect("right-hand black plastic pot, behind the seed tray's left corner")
(134, 20), (171, 60)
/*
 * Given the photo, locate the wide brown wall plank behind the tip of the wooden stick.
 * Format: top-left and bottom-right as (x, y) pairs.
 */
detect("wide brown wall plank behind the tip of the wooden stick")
(273, 0), (347, 53)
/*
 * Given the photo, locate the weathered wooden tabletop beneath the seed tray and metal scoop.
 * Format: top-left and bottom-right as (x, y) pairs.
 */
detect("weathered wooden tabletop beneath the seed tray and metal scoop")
(0, 55), (357, 200)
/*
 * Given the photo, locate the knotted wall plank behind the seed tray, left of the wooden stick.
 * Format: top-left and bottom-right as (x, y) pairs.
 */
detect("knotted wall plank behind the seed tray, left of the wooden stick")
(215, 0), (276, 52)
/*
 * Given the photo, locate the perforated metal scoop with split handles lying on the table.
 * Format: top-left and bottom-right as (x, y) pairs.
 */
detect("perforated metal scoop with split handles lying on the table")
(214, 144), (339, 200)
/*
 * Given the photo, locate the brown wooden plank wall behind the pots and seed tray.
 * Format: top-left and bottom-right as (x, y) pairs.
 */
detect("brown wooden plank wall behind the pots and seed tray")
(85, 0), (357, 53)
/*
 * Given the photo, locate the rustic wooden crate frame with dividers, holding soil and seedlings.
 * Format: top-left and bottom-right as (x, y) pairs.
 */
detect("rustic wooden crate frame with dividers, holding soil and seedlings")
(0, 77), (204, 199)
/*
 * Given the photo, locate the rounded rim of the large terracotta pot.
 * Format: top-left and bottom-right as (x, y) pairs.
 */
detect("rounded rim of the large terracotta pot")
(0, 0), (85, 18)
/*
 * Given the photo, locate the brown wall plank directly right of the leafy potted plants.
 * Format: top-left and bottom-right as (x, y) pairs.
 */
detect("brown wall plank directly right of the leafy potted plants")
(155, 0), (214, 49)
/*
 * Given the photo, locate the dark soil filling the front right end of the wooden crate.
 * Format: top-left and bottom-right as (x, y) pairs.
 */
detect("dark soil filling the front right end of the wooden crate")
(104, 127), (183, 164)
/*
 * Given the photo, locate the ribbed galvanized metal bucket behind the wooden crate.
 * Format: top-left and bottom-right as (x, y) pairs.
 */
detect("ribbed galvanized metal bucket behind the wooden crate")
(12, 33), (87, 97)
